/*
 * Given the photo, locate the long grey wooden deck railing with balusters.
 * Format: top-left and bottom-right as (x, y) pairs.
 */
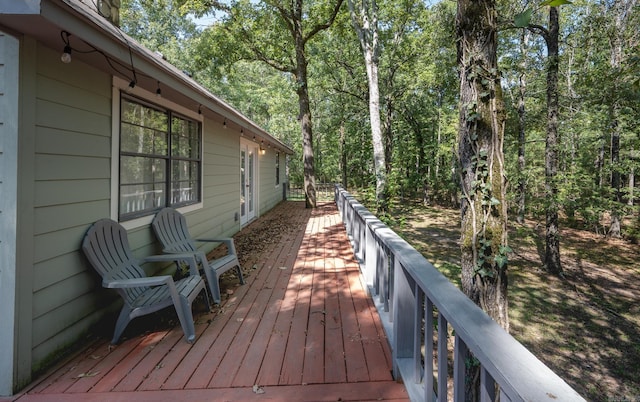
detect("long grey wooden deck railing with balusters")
(335, 185), (584, 401)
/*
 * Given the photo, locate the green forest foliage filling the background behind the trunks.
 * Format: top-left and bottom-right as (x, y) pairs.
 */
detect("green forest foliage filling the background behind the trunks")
(121, 0), (640, 242)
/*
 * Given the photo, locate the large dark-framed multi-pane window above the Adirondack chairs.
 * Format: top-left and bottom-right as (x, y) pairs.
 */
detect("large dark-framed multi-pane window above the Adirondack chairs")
(118, 94), (202, 221)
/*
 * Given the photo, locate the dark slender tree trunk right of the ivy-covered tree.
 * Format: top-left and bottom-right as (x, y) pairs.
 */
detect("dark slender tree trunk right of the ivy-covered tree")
(544, 7), (562, 275)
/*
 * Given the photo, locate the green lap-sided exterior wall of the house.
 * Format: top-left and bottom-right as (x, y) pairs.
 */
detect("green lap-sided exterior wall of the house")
(5, 35), (284, 395)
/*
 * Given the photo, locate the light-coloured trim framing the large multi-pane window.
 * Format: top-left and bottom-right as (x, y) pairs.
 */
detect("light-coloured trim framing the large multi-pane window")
(110, 77), (205, 230)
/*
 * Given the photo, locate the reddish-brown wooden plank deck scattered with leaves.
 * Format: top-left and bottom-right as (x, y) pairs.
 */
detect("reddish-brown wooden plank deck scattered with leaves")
(13, 202), (408, 402)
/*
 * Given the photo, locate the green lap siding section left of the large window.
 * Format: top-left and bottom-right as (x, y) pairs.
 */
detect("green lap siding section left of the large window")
(32, 46), (112, 368)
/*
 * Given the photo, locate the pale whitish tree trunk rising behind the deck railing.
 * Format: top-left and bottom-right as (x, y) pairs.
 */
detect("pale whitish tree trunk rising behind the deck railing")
(348, 0), (388, 212)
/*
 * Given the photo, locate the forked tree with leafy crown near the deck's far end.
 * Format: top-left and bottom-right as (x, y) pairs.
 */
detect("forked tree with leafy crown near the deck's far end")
(178, 0), (342, 208)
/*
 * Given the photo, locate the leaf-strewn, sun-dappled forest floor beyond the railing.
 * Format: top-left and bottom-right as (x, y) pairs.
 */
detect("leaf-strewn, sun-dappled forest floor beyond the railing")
(391, 201), (640, 401)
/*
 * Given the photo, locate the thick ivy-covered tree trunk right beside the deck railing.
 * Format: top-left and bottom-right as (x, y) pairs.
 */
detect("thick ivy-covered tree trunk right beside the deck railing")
(456, 0), (509, 330)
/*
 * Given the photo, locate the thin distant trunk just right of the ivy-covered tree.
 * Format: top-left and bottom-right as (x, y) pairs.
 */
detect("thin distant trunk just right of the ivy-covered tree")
(516, 29), (529, 224)
